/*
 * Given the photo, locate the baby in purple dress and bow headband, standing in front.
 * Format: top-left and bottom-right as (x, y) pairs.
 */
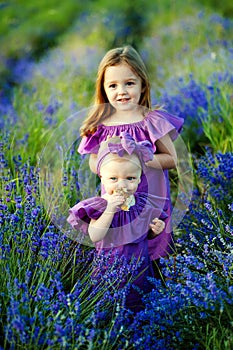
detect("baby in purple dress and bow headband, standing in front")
(68, 133), (166, 311)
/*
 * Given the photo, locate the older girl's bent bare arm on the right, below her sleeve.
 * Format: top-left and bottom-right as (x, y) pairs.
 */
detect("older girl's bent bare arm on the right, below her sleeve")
(146, 134), (177, 169)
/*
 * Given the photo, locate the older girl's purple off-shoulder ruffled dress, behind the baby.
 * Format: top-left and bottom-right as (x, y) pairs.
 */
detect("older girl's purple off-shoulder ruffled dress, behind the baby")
(78, 110), (184, 260)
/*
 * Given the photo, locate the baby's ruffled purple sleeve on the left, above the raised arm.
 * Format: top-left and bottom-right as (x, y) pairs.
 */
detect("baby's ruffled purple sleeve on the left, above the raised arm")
(67, 197), (107, 235)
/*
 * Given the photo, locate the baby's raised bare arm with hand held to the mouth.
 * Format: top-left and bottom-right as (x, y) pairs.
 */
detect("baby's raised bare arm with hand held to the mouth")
(88, 193), (125, 242)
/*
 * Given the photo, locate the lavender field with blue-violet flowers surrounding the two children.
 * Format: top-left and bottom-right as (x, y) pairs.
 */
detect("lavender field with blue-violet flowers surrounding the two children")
(0, 0), (233, 350)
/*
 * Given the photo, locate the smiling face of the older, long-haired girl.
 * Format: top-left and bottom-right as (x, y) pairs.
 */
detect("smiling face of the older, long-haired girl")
(104, 63), (142, 111)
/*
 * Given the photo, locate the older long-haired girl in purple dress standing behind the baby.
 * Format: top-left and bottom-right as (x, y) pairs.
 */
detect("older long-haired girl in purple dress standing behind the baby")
(78, 46), (183, 261)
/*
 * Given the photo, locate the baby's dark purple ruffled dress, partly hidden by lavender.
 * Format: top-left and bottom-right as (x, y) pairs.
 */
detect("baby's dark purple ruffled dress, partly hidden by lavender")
(67, 192), (166, 311)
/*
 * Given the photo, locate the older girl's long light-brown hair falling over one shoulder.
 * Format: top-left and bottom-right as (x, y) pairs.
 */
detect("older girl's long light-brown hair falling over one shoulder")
(80, 45), (151, 136)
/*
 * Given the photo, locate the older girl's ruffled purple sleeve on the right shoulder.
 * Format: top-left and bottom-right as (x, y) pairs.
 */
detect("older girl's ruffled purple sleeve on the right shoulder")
(145, 109), (184, 143)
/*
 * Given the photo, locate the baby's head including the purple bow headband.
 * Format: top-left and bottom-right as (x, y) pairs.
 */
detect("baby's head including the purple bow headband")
(97, 133), (153, 198)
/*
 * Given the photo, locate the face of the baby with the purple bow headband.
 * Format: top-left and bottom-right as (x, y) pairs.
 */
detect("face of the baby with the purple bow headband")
(100, 155), (141, 195)
